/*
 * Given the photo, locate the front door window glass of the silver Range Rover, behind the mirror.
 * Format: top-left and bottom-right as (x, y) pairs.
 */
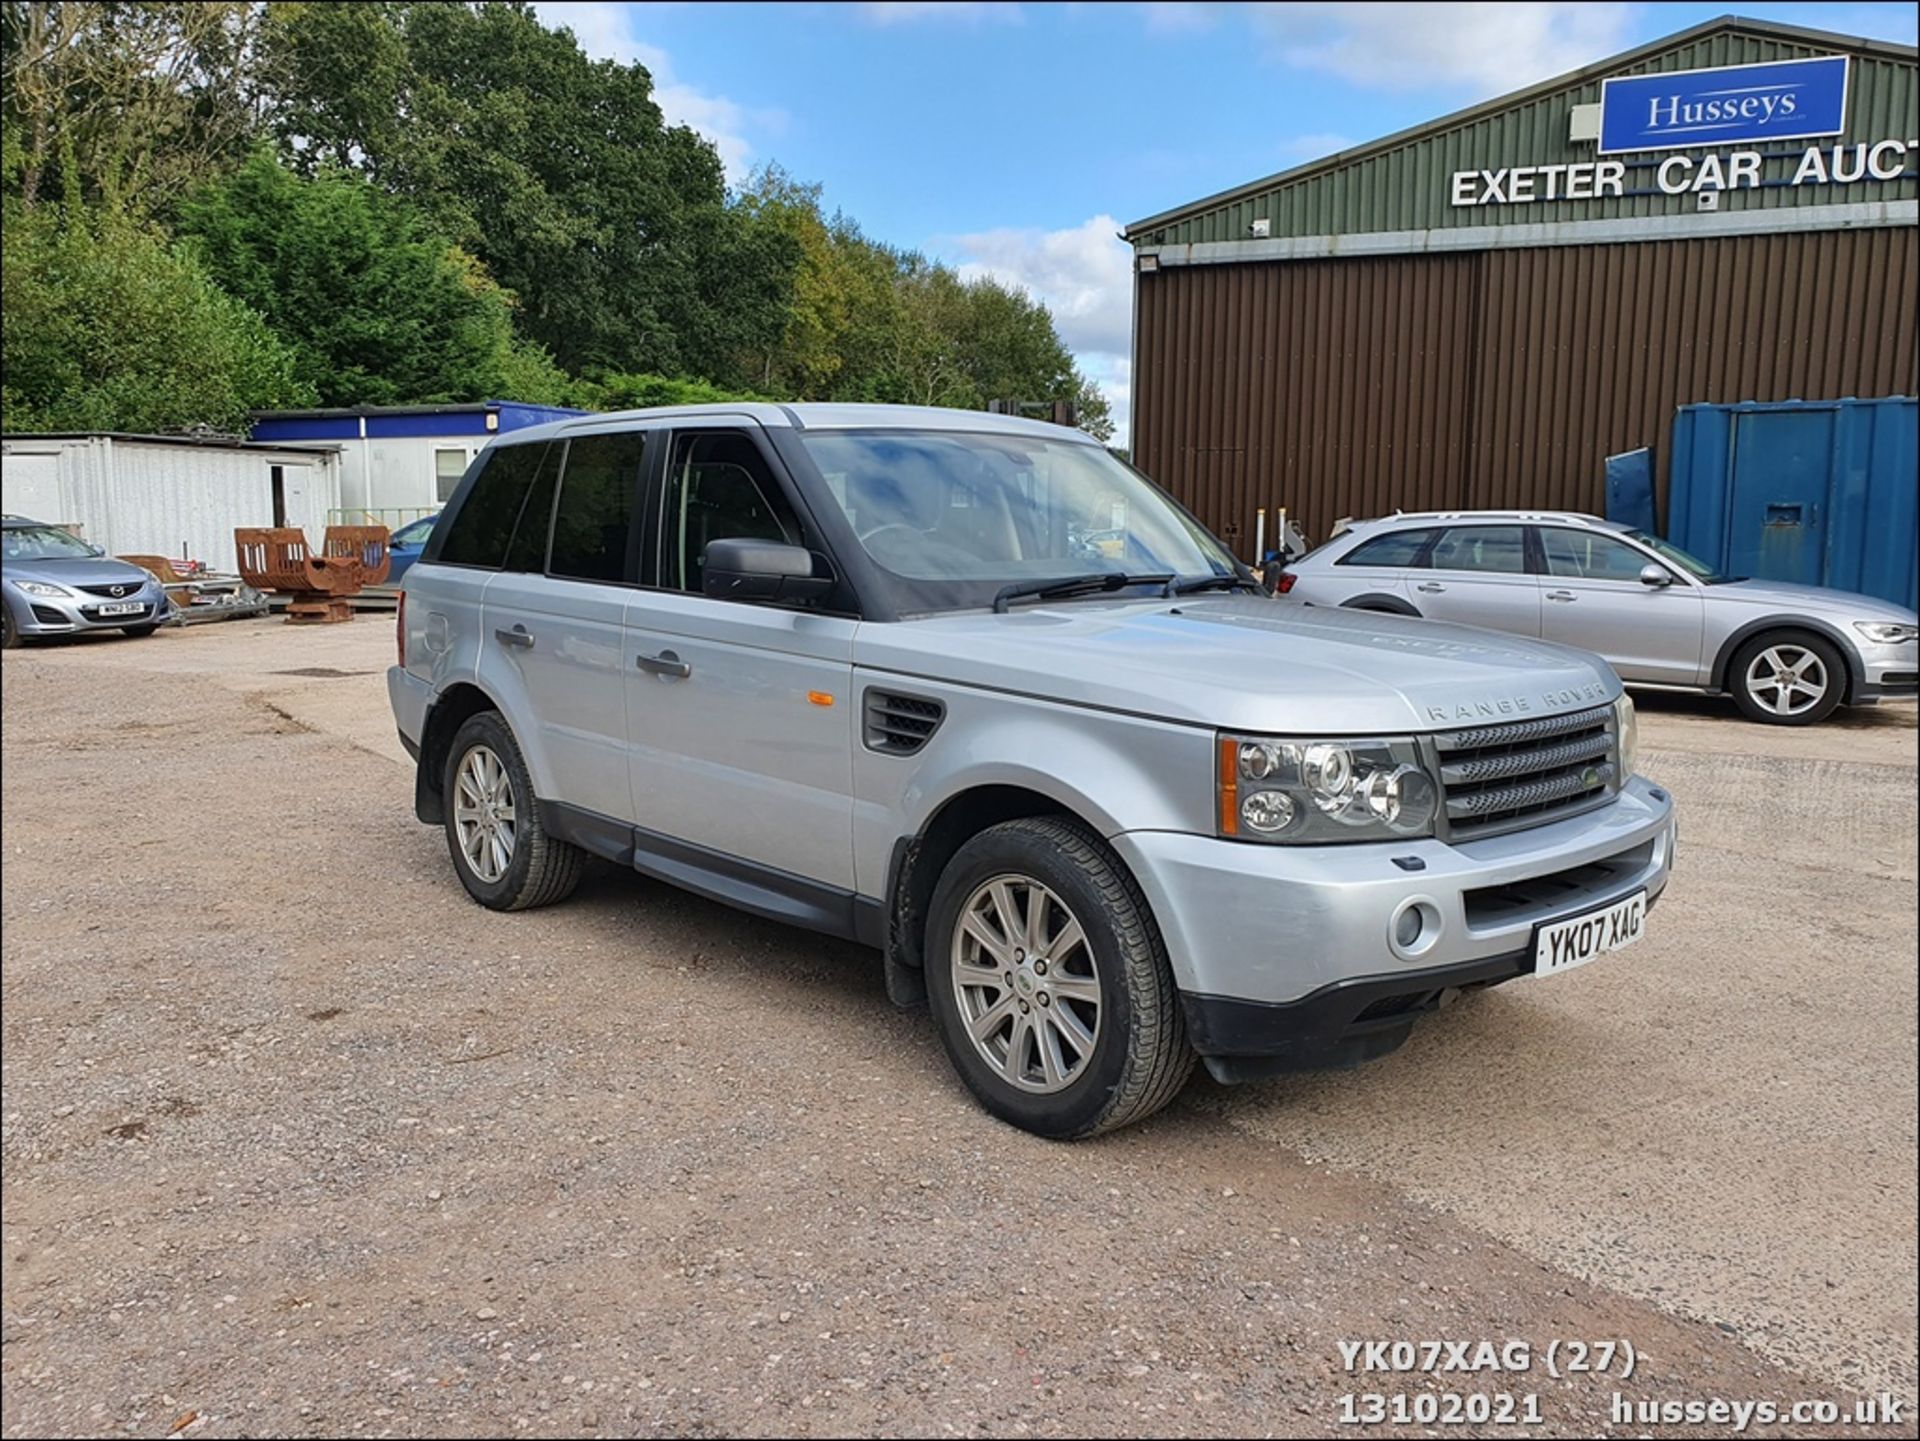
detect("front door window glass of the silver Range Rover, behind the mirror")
(660, 432), (801, 595)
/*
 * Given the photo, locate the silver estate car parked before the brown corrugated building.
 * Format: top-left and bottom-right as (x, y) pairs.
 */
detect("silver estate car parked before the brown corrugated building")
(1279, 510), (1920, 725)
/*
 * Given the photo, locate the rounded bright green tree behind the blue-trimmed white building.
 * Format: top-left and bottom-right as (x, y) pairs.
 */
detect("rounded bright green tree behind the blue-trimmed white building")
(180, 154), (564, 405)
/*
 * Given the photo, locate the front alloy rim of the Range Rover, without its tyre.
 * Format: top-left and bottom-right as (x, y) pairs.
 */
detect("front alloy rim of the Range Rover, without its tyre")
(952, 875), (1106, 1094)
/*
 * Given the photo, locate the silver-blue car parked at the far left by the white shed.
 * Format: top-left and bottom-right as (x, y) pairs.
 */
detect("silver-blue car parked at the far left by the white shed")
(0, 516), (167, 647)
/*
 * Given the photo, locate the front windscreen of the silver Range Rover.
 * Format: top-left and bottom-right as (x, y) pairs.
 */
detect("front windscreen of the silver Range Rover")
(801, 430), (1236, 610)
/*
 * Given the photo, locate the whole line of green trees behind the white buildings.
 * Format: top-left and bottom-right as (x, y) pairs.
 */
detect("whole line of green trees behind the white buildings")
(0, 0), (1112, 439)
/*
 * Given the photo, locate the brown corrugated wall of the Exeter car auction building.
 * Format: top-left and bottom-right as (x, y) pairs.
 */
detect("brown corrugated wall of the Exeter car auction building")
(1133, 228), (1920, 558)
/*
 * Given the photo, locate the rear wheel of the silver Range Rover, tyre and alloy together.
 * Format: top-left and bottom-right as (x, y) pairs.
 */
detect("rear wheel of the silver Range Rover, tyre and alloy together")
(444, 710), (588, 911)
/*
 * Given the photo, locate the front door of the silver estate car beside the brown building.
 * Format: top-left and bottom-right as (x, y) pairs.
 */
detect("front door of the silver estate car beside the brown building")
(1538, 526), (1707, 685)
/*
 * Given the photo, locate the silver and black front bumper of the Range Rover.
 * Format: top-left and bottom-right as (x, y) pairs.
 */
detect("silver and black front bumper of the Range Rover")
(1114, 777), (1674, 1080)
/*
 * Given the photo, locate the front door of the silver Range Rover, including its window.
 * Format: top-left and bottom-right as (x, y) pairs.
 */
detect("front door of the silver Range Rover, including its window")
(626, 426), (856, 892)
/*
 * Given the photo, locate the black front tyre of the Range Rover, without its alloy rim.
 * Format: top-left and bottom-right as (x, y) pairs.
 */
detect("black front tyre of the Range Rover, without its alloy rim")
(925, 817), (1194, 1140)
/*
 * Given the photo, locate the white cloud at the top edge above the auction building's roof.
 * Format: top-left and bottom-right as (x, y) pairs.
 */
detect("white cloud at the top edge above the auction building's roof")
(1248, 0), (1638, 94)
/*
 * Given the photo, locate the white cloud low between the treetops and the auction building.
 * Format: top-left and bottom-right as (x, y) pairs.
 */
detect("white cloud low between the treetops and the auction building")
(933, 215), (1133, 443)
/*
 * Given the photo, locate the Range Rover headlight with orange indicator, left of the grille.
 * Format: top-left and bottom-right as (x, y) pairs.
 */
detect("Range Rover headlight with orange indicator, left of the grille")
(1215, 735), (1440, 844)
